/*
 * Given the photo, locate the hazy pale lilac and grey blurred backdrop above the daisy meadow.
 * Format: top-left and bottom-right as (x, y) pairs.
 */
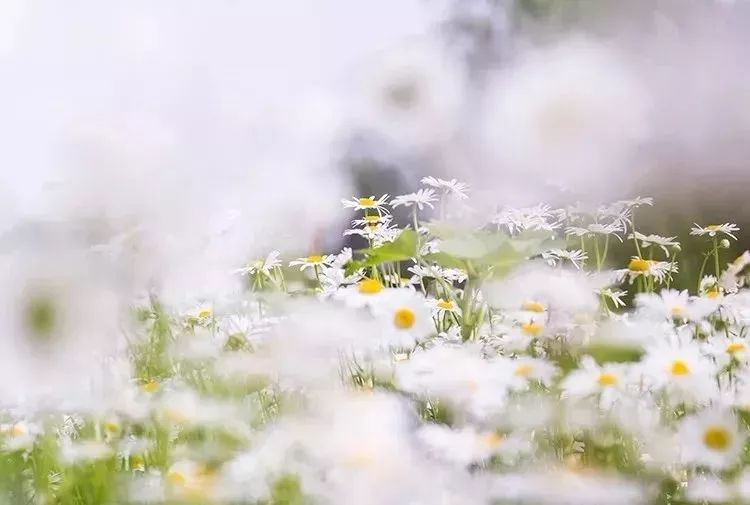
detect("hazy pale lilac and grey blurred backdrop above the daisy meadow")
(0, 0), (750, 292)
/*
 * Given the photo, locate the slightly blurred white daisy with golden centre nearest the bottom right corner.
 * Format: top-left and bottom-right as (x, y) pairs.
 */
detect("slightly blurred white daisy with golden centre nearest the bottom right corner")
(679, 409), (746, 470)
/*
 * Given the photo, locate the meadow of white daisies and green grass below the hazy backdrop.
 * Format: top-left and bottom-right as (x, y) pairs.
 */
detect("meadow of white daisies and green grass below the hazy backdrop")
(0, 177), (750, 505)
